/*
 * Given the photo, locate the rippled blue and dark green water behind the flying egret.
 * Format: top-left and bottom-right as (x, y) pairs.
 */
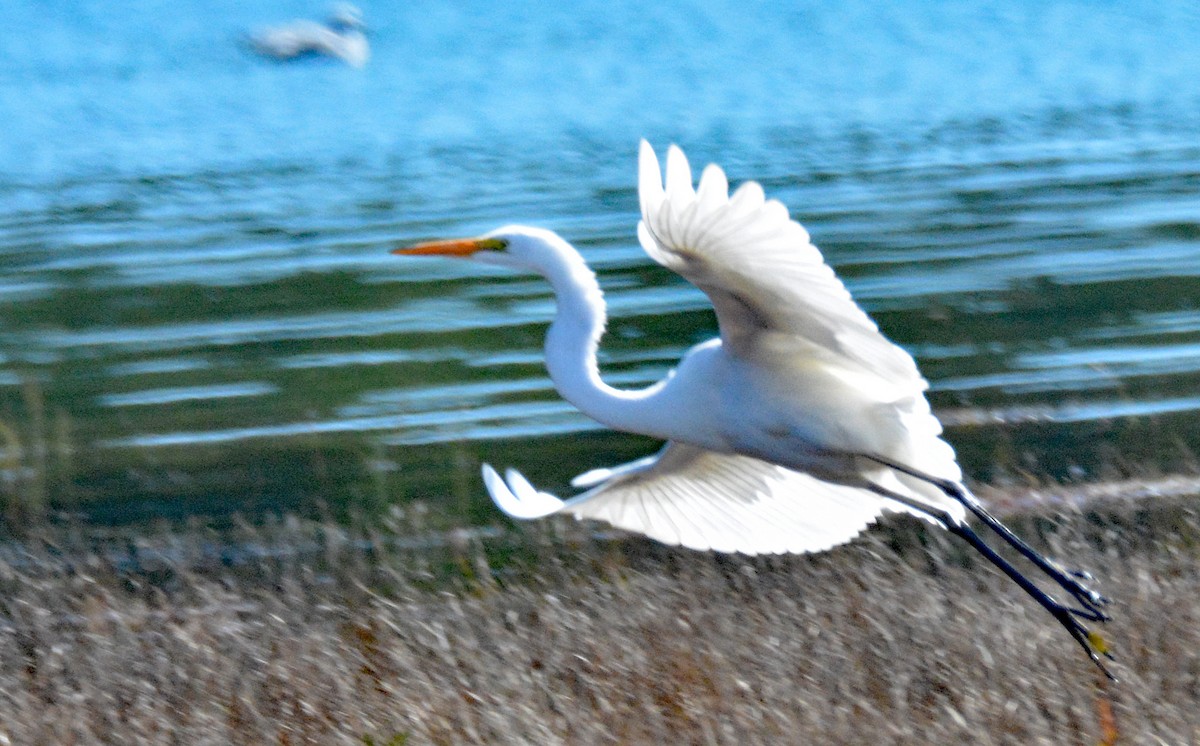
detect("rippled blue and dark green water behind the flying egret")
(0, 1), (1200, 522)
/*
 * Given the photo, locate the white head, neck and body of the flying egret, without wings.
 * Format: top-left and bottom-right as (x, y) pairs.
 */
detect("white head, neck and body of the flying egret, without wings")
(530, 227), (960, 491)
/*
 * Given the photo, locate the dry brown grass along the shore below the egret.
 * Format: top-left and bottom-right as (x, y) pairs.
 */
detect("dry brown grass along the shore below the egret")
(0, 498), (1200, 745)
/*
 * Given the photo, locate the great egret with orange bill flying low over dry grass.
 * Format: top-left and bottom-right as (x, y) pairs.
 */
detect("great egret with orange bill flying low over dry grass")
(394, 140), (1111, 676)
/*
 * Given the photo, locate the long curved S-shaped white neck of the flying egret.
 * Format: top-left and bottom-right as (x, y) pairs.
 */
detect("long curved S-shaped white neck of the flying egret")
(542, 239), (680, 439)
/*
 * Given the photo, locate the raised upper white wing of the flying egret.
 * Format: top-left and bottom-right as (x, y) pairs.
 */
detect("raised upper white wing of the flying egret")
(637, 140), (925, 391)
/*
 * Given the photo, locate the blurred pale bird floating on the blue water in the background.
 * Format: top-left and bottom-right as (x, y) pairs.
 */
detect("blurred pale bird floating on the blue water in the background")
(246, 2), (371, 67)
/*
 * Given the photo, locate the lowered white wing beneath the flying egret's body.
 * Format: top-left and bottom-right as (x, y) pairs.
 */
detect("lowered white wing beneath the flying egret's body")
(484, 443), (908, 554)
